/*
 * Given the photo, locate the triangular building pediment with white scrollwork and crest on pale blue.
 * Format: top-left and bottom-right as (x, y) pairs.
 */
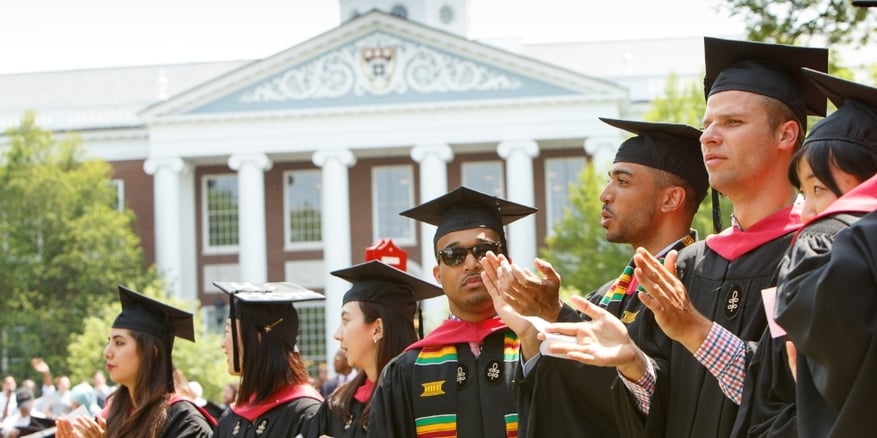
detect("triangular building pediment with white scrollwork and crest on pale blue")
(143, 11), (625, 120)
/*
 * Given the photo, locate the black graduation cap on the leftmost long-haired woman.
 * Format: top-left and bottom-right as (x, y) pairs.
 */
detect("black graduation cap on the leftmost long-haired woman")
(113, 285), (195, 392)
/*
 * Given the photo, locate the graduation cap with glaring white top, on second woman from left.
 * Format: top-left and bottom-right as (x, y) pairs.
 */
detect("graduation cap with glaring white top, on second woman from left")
(213, 281), (326, 371)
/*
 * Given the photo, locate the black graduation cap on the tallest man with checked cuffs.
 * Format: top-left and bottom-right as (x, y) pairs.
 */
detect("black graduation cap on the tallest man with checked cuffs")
(703, 37), (828, 127)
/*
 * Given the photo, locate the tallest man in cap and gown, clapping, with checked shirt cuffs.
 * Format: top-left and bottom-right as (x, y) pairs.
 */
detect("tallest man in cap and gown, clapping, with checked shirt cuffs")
(532, 38), (828, 438)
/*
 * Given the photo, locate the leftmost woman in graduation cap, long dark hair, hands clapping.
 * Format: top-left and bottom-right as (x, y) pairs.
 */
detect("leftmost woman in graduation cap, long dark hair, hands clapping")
(57, 286), (214, 438)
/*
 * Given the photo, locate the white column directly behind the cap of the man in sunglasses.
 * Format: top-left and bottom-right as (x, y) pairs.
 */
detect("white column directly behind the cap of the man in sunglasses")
(411, 143), (454, 333)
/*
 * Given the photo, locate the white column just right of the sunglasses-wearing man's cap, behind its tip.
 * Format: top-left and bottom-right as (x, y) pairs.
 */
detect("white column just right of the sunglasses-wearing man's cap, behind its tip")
(497, 140), (539, 269)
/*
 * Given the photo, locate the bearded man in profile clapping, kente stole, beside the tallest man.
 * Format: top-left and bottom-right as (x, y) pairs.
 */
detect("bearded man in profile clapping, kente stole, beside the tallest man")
(482, 119), (709, 438)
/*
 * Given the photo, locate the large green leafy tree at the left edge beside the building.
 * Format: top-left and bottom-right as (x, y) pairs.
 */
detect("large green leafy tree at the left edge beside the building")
(0, 113), (158, 377)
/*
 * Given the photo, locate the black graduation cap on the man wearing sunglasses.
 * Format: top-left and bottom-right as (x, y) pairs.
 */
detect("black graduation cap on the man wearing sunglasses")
(399, 186), (536, 251)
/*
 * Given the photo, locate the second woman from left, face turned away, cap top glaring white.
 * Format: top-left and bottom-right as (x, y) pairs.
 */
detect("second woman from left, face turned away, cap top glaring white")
(213, 282), (325, 438)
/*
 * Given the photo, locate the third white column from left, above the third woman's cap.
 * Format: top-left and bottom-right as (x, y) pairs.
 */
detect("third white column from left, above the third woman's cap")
(311, 149), (356, 364)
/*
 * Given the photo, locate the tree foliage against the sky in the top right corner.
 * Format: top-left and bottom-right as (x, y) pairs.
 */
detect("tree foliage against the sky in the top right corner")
(720, 0), (874, 47)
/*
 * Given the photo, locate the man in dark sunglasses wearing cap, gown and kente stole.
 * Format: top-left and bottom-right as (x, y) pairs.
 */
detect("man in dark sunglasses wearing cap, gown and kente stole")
(368, 187), (536, 438)
